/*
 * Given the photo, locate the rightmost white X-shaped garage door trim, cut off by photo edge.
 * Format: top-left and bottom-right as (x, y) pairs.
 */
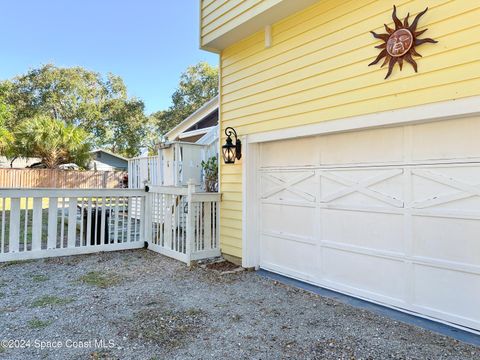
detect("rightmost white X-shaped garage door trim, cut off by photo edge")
(412, 169), (480, 209)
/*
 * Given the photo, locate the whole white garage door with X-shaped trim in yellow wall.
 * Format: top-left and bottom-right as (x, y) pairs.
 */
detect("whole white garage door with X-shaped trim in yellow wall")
(258, 118), (480, 330)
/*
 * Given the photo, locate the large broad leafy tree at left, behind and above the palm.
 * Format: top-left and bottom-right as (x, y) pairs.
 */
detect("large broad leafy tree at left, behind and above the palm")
(0, 64), (147, 156)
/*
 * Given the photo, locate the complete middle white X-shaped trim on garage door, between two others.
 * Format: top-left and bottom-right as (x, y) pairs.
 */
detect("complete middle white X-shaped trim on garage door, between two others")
(321, 169), (403, 207)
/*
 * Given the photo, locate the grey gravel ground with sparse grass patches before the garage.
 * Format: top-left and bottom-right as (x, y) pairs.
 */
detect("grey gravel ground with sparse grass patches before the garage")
(0, 250), (480, 360)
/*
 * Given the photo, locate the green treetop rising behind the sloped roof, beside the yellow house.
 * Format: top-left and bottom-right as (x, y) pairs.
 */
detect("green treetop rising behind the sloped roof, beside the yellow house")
(150, 62), (218, 141)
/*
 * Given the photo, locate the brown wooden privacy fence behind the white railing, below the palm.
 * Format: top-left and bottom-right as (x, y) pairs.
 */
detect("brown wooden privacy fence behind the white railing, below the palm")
(0, 169), (127, 189)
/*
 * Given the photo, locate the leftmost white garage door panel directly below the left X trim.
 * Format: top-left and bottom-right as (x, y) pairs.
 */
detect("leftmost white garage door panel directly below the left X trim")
(261, 204), (318, 241)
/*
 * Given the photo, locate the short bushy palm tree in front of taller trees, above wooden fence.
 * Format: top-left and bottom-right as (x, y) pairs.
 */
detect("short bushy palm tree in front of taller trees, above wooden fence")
(13, 115), (91, 169)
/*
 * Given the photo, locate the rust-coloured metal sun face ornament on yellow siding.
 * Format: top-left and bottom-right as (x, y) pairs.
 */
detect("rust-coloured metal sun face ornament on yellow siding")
(368, 5), (438, 79)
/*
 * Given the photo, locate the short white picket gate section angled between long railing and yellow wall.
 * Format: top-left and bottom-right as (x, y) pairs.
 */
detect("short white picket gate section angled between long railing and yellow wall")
(147, 183), (220, 264)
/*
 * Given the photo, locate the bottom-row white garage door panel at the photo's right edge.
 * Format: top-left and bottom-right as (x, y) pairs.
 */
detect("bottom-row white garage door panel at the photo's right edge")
(413, 264), (480, 329)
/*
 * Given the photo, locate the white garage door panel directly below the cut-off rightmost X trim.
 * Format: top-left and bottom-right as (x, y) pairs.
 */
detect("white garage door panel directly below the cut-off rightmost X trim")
(412, 216), (480, 266)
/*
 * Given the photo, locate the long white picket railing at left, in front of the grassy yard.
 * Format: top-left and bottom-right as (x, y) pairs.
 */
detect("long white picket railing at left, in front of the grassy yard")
(0, 189), (147, 261)
